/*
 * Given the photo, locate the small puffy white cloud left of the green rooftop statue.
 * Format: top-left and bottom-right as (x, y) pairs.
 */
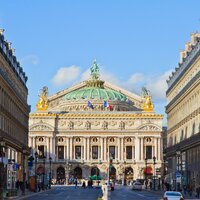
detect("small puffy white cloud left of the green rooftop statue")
(52, 66), (80, 86)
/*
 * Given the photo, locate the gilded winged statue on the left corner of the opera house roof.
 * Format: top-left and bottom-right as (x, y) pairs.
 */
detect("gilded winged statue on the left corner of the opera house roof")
(36, 86), (48, 111)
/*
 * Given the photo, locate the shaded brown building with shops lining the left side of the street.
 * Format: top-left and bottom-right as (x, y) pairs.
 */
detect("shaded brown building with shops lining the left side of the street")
(0, 29), (30, 198)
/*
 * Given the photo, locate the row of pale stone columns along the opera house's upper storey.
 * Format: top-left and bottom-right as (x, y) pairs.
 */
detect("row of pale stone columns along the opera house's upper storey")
(29, 135), (162, 162)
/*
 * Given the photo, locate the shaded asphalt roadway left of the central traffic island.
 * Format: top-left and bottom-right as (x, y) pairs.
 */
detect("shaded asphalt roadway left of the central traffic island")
(24, 186), (101, 200)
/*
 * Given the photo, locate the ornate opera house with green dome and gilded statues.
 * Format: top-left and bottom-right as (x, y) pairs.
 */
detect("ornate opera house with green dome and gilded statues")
(29, 62), (163, 184)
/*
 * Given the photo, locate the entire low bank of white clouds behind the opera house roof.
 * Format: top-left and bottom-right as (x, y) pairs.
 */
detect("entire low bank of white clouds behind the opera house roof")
(52, 63), (172, 101)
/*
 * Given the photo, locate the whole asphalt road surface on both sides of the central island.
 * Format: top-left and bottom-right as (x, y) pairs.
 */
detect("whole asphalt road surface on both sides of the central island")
(15, 185), (198, 200)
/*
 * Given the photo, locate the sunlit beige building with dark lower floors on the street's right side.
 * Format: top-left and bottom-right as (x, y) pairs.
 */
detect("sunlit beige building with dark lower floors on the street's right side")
(166, 33), (200, 188)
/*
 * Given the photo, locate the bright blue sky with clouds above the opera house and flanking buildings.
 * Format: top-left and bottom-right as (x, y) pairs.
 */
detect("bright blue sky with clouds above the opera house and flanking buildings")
(0, 0), (200, 124)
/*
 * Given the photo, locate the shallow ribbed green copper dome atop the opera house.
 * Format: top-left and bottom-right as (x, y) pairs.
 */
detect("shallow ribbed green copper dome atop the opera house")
(64, 87), (127, 101)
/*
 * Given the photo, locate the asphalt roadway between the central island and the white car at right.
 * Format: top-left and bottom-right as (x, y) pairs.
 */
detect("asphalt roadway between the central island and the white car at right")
(111, 186), (162, 200)
